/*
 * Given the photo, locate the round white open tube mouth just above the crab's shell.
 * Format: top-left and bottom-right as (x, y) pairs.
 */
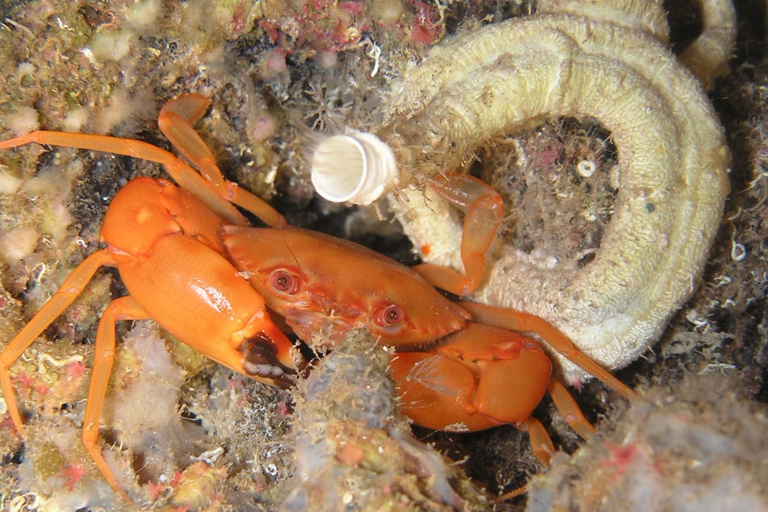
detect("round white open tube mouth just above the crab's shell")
(311, 131), (398, 205)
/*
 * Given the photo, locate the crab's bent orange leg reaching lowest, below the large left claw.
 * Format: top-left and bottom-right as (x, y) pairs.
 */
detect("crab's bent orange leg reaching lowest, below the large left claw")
(83, 295), (150, 501)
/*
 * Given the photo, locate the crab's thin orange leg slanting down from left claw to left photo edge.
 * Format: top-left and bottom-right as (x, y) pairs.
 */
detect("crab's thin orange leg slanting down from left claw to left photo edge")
(0, 249), (114, 434)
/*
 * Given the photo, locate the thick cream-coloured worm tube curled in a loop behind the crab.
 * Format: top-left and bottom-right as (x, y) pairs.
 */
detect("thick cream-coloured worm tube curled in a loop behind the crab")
(378, 2), (729, 375)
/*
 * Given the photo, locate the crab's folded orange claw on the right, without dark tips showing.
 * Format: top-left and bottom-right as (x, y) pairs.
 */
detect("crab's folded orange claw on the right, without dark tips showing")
(392, 323), (552, 431)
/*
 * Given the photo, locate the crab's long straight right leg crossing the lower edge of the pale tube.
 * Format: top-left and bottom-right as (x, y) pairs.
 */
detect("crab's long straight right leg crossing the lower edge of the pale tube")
(458, 302), (636, 398)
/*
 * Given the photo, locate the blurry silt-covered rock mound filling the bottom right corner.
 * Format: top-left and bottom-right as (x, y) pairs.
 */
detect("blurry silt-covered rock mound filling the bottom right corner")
(527, 373), (768, 512)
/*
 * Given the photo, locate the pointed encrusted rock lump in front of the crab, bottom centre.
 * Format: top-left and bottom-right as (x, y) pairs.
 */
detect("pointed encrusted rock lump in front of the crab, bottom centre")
(281, 331), (488, 512)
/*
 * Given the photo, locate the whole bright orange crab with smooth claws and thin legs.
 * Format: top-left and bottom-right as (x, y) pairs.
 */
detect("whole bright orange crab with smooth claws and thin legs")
(0, 94), (633, 498)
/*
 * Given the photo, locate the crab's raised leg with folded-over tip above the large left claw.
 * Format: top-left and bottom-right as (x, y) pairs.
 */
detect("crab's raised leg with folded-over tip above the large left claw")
(158, 93), (288, 227)
